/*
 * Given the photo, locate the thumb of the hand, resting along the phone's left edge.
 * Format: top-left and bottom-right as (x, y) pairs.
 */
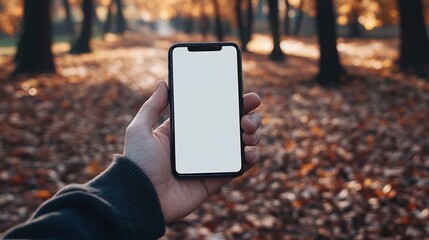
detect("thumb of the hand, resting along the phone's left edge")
(133, 81), (168, 133)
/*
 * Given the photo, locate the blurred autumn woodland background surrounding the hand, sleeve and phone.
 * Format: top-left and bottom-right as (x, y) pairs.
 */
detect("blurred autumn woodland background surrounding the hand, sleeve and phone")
(0, 0), (429, 239)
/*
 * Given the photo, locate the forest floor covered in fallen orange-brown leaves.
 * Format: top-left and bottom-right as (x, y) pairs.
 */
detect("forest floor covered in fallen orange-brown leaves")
(0, 32), (429, 239)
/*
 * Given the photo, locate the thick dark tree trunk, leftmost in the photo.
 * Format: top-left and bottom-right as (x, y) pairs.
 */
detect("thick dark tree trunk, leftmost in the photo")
(13, 0), (55, 75)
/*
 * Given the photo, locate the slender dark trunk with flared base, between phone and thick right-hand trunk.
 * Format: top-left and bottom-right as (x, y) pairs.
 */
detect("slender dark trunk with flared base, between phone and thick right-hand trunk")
(268, 0), (286, 61)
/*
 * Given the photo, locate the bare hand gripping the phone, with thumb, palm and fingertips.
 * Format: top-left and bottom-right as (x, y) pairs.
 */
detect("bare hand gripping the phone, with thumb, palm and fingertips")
(124, 81), (261, 223)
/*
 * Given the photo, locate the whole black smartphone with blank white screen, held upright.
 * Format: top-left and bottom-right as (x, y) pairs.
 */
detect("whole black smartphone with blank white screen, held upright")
(168, 42), (244, 178)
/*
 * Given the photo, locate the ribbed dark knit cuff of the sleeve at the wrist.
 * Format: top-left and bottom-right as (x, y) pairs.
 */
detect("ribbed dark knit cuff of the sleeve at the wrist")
(86, 155), (165, 239)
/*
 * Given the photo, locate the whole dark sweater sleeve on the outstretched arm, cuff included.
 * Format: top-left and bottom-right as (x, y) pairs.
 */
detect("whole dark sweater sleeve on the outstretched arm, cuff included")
(4, 155), (165, 239)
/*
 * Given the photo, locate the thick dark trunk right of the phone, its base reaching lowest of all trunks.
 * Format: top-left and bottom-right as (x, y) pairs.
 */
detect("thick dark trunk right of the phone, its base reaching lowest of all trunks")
(316, 0), (343, 87)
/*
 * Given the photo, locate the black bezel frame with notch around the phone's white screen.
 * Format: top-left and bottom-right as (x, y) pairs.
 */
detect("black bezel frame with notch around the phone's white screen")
(168, 42), (245, 178)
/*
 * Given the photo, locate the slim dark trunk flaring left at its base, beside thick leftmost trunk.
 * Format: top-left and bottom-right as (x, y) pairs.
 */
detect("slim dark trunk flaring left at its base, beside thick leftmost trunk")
(70, 0), (93, 54)
